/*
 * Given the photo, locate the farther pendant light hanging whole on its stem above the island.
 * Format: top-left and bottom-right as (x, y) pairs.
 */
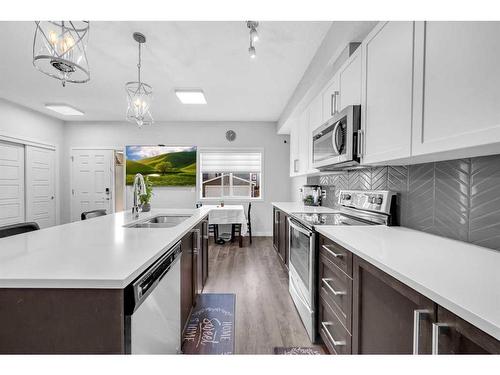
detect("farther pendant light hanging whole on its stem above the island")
(125, 33), (153, 127)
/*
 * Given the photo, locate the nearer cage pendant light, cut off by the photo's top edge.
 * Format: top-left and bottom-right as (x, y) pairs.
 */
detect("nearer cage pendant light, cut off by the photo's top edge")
(33, 21), (90, 86)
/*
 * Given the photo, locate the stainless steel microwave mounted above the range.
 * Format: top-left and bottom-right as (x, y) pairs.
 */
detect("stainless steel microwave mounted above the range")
(312, 105), (361, 170)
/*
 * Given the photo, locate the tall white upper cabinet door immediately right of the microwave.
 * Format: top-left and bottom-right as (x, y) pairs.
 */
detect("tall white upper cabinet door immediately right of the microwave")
(361, 22), (414, 164)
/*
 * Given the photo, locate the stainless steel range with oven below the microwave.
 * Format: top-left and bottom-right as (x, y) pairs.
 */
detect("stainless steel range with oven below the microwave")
(288, 190), (395, 341)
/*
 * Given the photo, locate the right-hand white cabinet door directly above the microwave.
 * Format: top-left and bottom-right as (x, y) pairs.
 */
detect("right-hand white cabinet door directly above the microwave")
(338, 48), (361, 111)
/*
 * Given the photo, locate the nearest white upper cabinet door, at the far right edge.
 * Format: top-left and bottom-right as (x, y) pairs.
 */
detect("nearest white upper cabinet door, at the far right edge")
(412, 22), (500, 158)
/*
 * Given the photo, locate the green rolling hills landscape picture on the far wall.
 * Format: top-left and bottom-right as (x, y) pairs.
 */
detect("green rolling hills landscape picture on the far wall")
(125, 146), (196, 186)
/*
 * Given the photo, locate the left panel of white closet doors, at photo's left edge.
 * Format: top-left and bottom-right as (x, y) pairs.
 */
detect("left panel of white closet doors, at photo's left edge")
(0, 142), (25, 226)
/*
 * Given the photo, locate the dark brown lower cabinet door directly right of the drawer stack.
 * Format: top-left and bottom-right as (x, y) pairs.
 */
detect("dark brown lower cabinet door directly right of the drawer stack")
(352, 256), (436, 354)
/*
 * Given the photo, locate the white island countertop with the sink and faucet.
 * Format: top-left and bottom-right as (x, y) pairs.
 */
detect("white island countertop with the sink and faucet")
(0, 207), (210, 289)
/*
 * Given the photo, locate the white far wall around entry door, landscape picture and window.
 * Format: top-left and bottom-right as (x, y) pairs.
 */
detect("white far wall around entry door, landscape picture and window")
(62, 122), (290, 235)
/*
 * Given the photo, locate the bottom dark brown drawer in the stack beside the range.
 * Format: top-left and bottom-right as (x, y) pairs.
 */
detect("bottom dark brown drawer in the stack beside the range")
(318, 297), (352, 354)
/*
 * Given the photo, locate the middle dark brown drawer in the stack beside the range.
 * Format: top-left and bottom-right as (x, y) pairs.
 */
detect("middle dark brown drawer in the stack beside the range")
(318, 254), (352, 332)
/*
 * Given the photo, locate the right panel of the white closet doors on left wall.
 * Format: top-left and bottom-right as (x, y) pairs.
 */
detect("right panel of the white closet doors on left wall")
(26, 146), (56, 228)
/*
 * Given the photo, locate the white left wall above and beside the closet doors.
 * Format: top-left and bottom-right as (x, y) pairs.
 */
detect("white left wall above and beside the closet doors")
(0, 98), (64, 223)
